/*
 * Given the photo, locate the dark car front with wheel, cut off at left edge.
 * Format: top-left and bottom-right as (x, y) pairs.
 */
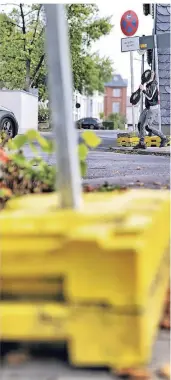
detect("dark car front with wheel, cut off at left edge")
(0, 106), (18, 137)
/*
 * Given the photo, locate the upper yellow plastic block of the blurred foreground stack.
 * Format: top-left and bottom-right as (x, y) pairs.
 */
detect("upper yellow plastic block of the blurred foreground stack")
(0, 190), (170, 307)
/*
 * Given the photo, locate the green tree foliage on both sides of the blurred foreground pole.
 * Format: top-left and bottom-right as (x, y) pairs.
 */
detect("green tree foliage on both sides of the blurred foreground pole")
(0, 4), (112, 98)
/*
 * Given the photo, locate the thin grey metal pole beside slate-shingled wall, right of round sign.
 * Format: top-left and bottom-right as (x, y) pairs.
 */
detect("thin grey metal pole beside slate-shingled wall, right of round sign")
(153, 4), (161, 132)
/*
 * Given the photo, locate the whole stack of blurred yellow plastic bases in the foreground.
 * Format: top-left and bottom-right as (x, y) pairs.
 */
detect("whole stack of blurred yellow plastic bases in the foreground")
(0, 190), (170, 368)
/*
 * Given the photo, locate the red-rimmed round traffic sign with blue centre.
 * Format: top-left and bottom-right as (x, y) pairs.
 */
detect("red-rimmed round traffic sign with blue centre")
(120, 11), (139, 37)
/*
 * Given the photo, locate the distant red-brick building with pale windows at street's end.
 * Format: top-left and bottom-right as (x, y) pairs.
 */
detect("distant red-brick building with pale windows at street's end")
(104, 74), (128, 117)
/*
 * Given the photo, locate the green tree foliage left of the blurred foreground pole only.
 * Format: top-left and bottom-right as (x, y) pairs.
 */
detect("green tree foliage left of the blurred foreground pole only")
(0, 4), (45, 89)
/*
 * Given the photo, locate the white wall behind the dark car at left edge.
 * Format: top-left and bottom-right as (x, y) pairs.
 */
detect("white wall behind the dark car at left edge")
(0, 90), (38, 134)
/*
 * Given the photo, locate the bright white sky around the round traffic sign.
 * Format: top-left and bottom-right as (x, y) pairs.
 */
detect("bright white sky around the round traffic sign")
(93, 0), (153, 94)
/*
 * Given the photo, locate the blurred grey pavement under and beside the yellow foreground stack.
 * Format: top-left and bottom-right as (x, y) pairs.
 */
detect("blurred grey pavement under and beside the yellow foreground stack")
(0, 332), (170, 380)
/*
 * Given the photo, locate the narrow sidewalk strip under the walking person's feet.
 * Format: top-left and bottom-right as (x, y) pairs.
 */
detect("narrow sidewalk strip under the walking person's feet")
(109, 146), (170, 156)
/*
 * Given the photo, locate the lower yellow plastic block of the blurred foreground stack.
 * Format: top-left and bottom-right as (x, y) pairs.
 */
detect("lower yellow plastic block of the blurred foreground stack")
(0, 251), (169, 369)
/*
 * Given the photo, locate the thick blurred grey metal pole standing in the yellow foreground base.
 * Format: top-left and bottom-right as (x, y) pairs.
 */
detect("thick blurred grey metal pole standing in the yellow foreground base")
(45, 4), (81, 208)
